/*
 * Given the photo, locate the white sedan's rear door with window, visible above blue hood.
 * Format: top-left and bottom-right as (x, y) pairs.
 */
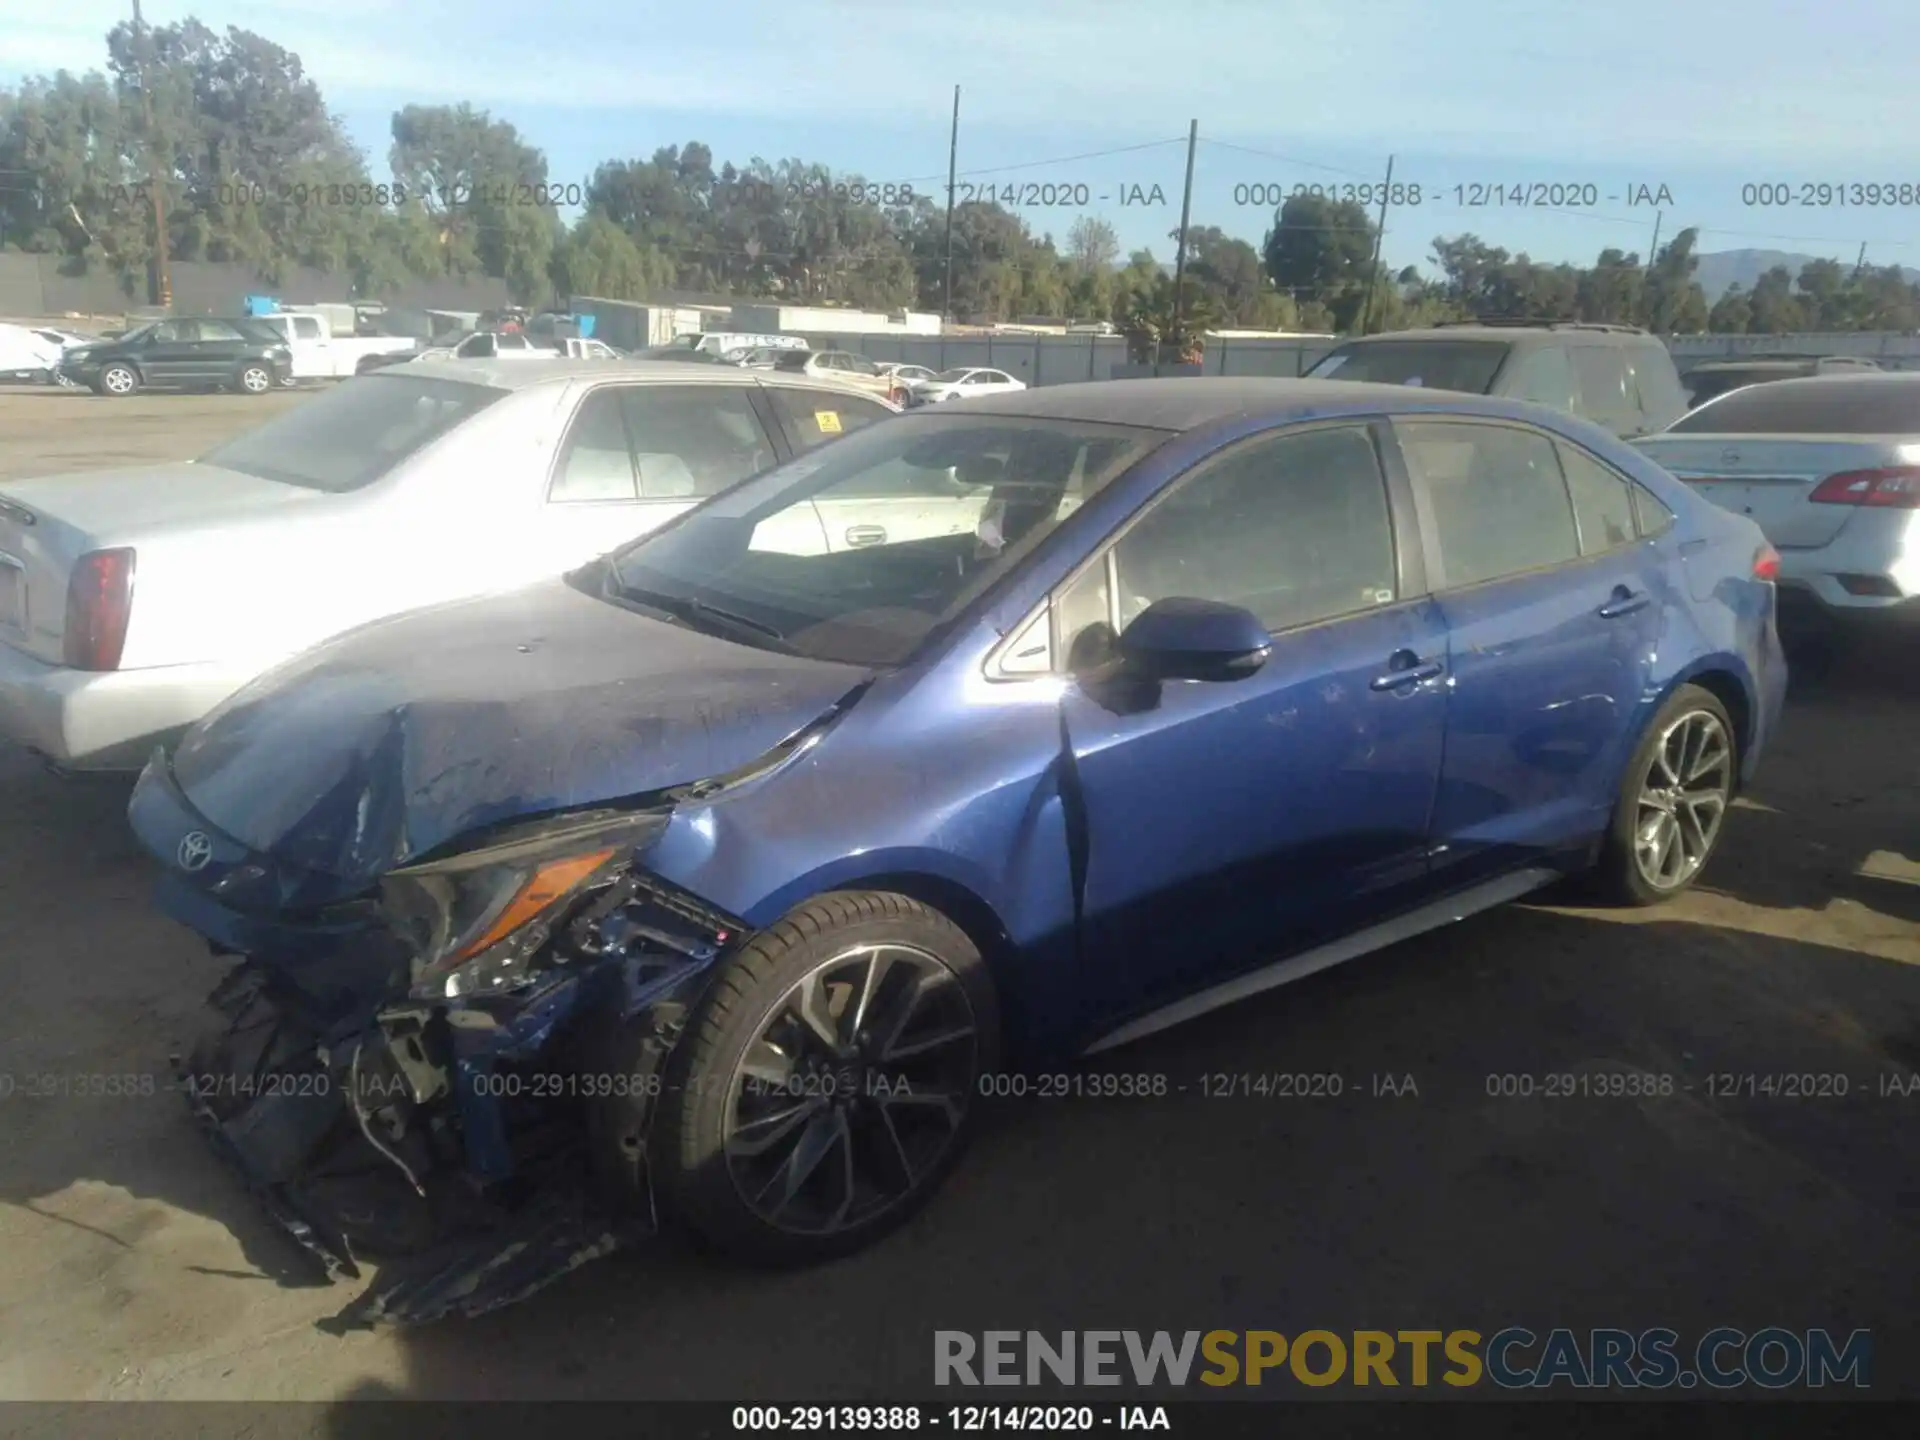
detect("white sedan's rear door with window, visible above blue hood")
(532, 384), (778, 574)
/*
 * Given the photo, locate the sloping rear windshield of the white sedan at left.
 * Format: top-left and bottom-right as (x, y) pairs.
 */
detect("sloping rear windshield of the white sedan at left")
(200, 371), (507, 493)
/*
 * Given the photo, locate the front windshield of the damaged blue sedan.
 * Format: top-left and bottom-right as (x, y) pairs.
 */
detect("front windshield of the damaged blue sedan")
(609, 417), (1164, 664)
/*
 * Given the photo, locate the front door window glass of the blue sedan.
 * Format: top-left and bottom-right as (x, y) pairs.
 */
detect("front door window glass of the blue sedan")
(1056, 424), (1398, 668)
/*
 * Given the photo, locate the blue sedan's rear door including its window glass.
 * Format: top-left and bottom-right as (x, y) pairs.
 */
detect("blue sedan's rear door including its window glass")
(1392, 407), (1667, 887)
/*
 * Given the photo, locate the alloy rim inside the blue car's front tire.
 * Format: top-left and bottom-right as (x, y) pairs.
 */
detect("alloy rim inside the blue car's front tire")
(726, 945), (979, 1235)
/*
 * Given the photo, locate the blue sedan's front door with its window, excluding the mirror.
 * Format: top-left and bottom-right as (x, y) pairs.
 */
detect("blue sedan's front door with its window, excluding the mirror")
(1054, 422), (1446, 1010)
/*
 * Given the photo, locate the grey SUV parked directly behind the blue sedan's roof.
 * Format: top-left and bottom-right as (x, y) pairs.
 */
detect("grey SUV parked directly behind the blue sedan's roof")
(1308, 323), (1688, 440)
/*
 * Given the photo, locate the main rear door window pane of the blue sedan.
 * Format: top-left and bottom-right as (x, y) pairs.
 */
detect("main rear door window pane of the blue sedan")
(1394, 420), (1580, 588)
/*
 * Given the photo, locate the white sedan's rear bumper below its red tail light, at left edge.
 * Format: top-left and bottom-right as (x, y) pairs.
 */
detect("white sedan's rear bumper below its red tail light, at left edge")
(0, 645), (252, 770)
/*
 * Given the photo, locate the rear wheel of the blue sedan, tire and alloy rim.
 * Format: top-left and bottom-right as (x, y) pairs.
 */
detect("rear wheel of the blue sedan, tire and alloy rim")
(1594, 685), (1740, 906)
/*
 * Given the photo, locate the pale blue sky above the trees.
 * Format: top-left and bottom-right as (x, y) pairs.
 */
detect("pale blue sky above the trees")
(11, 0), (1920, 276)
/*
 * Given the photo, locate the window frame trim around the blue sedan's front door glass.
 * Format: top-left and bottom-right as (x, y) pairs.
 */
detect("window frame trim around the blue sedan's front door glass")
(1036, 415), (1428, 682)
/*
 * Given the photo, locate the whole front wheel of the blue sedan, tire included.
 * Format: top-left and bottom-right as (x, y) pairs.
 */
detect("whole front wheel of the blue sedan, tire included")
(649, 891), (1000, 1265)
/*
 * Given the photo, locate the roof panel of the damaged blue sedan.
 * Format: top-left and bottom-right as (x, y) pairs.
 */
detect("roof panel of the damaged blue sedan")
(908, 378), (1540, 430)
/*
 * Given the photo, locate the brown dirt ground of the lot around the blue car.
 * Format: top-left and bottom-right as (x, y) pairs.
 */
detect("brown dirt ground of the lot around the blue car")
(0, 394), (1920, 1400)
